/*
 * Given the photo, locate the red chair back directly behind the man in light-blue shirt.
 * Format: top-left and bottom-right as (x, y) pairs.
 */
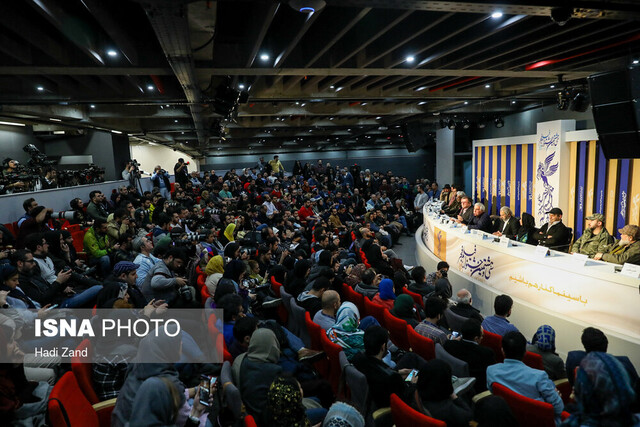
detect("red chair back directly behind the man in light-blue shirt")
(491, 383), (570, 427)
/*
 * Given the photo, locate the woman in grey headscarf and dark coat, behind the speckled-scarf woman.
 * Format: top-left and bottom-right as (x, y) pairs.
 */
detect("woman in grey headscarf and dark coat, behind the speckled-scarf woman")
(232, 328), (282, 425)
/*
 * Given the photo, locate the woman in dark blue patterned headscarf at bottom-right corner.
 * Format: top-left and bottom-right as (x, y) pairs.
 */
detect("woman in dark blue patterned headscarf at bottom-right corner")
(562, 351), (640, 427)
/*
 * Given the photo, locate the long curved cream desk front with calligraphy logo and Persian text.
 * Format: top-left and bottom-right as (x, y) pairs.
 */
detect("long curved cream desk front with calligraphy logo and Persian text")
(422, 215), (640, 341)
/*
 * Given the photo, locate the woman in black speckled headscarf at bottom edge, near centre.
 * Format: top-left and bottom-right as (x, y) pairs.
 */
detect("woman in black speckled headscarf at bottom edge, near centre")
(265, 376), (311, 427)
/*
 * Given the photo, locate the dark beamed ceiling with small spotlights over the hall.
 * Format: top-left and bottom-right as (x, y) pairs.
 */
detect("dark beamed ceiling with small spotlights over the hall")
(0, 0), (640, 155)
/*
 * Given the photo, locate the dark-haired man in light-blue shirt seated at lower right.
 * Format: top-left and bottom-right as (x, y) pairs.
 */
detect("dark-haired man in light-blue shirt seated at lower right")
(487, 331), (564, 418)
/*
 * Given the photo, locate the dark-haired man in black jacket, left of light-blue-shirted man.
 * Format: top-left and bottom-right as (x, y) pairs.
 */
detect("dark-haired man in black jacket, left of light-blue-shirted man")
(444, 319), (496, 393)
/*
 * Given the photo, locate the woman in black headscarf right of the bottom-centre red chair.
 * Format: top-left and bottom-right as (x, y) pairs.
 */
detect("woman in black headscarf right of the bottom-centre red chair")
(416, 359), (473, 427)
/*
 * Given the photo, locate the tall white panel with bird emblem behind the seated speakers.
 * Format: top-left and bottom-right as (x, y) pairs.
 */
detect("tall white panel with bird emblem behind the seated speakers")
(531, 120), (576, 227)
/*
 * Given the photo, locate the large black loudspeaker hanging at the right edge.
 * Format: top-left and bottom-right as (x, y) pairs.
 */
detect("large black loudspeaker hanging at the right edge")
(588, 67), (640, 159)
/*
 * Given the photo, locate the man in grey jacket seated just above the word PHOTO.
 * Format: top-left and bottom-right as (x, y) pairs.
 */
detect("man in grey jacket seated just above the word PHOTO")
(142, 247), (195, 308)
